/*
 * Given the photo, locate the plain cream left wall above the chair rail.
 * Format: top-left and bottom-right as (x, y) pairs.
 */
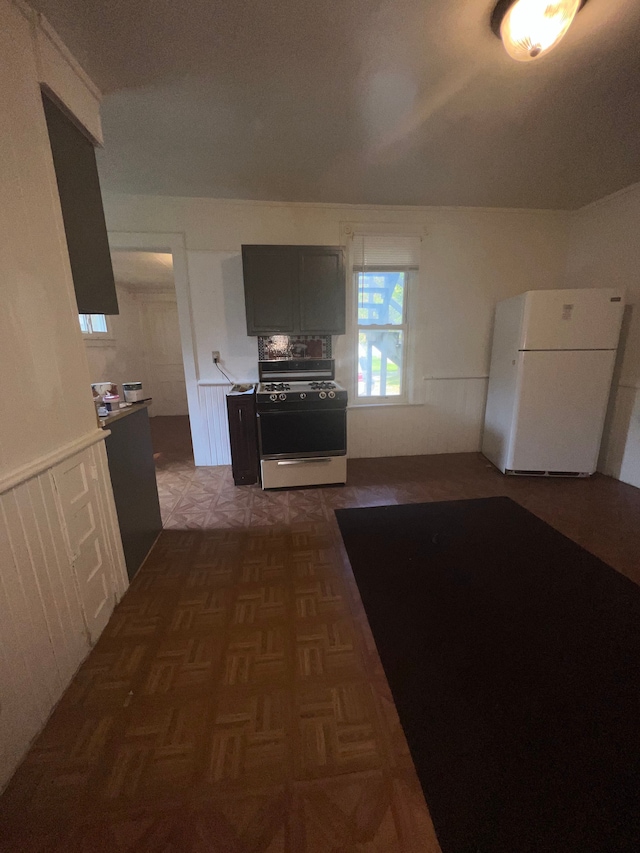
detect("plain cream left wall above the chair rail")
(0, 0), (98, 481)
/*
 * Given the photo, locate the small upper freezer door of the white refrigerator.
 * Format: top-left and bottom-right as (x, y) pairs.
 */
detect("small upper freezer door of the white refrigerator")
(519, 288), (624, 350)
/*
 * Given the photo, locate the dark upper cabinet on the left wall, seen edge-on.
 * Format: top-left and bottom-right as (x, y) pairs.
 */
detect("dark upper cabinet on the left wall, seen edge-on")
(42, 93), (118, 314)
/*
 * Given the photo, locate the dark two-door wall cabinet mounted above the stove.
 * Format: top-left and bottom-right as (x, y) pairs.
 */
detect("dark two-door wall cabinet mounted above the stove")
(242, 246), (345, 335)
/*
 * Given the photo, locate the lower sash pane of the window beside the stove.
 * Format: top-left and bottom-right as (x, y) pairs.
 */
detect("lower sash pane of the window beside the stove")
(358, 330), (403, 397)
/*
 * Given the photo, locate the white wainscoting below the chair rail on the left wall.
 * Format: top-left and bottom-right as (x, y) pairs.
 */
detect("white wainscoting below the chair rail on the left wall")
(0, 440), (127, 789)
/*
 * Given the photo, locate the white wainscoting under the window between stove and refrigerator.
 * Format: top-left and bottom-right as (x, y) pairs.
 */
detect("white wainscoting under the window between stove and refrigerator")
(347, 376), (488, 459)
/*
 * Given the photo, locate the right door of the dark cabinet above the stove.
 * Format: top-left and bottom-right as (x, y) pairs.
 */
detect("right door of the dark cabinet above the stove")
(299, 246), (345, 335)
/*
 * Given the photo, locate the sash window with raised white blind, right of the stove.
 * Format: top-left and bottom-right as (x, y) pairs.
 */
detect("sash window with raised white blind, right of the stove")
(352, 234), (420, 402)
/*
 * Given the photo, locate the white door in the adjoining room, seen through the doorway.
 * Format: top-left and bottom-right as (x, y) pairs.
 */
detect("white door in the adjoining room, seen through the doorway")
(140, 294), (188, 416)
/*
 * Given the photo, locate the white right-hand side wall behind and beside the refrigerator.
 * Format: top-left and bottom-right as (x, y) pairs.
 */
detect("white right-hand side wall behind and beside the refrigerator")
(566, 184), (640, 487)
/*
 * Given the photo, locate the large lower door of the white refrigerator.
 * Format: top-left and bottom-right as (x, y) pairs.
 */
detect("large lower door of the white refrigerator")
(506, 350), (615, 474)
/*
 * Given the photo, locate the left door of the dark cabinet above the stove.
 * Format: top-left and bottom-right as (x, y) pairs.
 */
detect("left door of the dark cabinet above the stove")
(242, 246), (299, 335)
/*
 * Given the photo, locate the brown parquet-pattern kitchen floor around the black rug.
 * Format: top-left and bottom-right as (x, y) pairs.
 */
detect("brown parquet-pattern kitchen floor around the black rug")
(0, 440), (640, 853)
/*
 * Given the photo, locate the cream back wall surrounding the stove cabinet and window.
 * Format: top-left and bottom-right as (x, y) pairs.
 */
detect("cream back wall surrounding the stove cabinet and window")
(105, 194), (569, 464)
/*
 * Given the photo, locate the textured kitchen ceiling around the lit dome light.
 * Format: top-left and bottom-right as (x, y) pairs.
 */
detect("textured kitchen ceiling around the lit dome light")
(33, 0), (640, 208)
